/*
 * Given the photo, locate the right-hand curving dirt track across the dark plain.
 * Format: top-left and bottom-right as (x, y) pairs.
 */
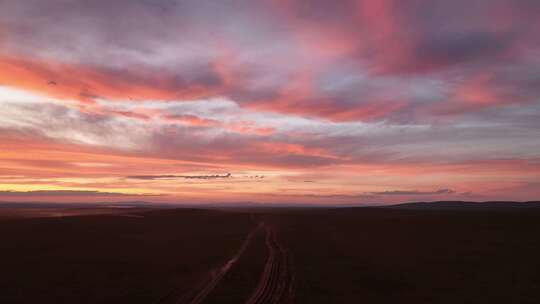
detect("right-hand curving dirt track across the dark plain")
(246, 225), (294, 304)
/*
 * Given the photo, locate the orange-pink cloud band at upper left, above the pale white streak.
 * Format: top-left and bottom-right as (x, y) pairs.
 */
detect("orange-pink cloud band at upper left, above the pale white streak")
(0, 56), (224, 103)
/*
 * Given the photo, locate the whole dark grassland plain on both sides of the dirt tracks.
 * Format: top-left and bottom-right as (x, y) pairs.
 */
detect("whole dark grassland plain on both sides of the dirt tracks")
(0, 207), (540, 304)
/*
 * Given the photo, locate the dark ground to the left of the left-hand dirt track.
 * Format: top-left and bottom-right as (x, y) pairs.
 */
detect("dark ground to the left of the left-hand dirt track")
(0, 210), (255, 303)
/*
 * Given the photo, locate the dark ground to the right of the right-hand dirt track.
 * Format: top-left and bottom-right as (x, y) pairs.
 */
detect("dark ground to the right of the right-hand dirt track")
(275, 209), (540, 303)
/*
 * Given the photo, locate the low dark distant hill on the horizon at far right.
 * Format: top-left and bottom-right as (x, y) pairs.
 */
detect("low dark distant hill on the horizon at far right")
(384, 201), (540, 210)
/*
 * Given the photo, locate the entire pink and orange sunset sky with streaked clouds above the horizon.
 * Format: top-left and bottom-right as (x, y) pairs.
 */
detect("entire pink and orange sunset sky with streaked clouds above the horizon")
(0, 0), (540, 205)
